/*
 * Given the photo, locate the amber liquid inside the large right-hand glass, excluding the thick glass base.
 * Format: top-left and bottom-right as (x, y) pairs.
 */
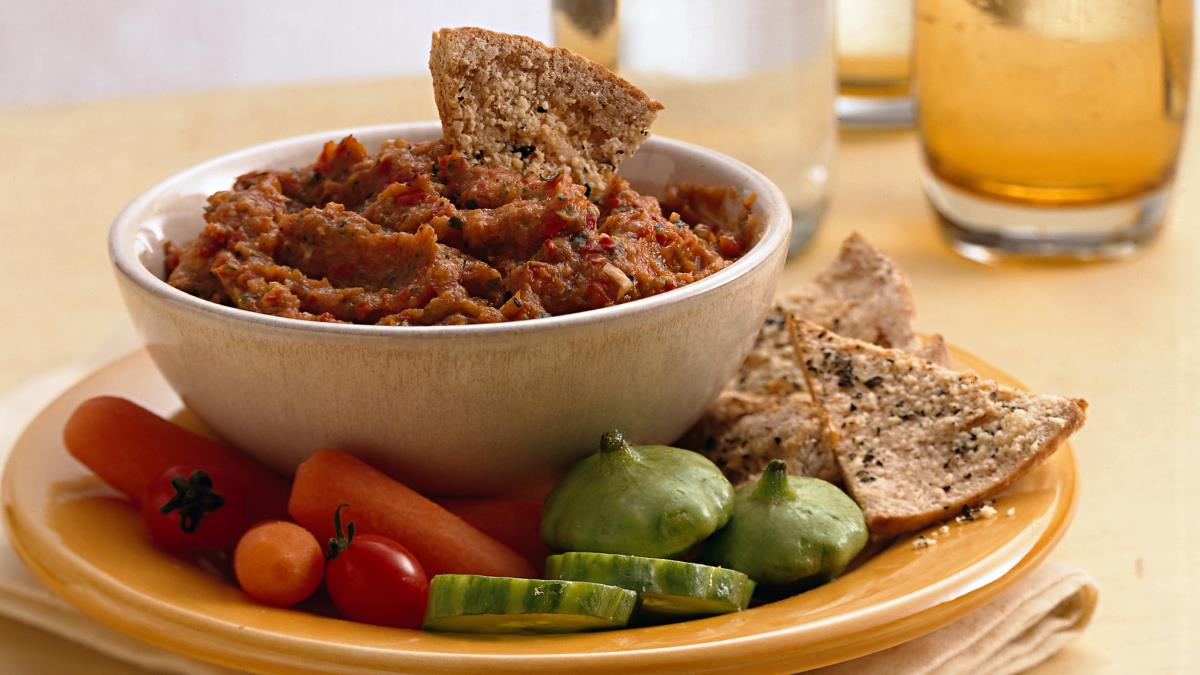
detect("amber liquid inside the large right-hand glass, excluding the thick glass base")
(913, 0), (1193, 207)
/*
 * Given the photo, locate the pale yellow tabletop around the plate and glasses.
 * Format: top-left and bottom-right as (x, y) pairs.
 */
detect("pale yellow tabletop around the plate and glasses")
(0, 78), (1200, 674)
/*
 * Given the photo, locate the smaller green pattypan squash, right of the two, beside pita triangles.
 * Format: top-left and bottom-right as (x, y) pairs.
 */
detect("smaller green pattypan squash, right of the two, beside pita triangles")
(701, 460), (868, 585)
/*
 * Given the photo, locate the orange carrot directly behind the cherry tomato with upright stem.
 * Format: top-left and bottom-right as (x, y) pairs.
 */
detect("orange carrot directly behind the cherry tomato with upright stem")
(288, 450), (534, 578)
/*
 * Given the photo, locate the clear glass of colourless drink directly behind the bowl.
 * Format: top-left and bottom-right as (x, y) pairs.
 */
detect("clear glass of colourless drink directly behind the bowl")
(553, 0), (836, 253)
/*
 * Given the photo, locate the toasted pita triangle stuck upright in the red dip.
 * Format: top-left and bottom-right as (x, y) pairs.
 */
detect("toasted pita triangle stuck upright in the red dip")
(430, 28), (662, 191)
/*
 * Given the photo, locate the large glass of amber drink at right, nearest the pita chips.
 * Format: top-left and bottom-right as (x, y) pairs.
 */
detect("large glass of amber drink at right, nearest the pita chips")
(913, 0), (1193, 261)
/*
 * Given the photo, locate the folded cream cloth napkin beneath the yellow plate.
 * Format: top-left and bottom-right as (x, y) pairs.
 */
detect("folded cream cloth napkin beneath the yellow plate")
(0, 366), (1099, 675)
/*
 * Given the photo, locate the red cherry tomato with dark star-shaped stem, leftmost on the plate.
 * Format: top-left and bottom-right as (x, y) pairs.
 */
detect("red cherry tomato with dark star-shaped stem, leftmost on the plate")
(142, 466), (250, 554)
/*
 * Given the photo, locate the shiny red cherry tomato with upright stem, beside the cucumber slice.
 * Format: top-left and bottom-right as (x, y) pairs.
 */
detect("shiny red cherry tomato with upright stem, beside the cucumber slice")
(325, 504), (430, 628)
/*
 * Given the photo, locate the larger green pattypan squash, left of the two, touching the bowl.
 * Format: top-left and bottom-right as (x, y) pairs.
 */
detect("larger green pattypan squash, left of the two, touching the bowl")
(541, 431), (733, 557)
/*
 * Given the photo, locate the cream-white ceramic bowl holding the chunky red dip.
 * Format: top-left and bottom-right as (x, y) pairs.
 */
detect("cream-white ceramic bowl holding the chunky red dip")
(109, 123), (791, 496)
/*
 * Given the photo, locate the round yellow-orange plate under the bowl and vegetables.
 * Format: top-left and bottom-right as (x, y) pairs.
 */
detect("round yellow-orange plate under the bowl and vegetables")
(4, 343), (1075, 673)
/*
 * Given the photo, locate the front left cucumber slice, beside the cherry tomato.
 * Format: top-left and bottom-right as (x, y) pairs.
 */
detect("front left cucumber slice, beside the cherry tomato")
(425, 574), (637, 633)
